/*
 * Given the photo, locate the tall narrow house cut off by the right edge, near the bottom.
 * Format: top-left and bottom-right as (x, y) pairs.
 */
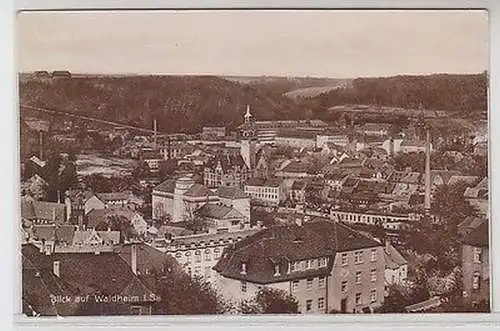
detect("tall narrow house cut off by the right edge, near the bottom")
(462, 221), (490, 305)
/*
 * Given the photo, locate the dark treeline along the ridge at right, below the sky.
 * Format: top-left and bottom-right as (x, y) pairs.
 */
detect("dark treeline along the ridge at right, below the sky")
(301, 72), (488, 114)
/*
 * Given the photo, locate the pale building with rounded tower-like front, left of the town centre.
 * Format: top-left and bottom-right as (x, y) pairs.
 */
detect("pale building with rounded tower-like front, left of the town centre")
(152, 175), (219, 223)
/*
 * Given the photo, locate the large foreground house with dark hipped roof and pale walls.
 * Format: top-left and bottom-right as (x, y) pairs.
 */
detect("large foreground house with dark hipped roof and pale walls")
(214, 218), (385, 314)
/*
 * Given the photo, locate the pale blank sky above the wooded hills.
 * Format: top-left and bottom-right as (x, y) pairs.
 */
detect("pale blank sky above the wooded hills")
(17, 10), (489, 78)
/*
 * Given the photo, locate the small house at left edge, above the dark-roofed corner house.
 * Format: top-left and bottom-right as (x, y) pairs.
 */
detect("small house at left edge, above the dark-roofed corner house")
(21, 198), (69, 224)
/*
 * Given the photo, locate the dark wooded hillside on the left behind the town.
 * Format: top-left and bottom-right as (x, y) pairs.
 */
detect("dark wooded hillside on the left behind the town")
(19, 76), (305, 133)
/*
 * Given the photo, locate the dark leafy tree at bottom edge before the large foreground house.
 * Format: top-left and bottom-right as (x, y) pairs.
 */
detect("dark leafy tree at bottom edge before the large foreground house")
(240, 287), (299, 314)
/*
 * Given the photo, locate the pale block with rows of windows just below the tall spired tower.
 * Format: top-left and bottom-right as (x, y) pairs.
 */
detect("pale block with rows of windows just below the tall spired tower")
(244, 178), (286, 205)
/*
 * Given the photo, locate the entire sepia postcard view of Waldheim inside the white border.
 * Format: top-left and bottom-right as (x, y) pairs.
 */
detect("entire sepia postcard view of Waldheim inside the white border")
(16, 9), (491, 318)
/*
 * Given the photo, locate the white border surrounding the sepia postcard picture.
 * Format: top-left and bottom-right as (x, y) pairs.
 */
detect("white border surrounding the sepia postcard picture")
(0, 0), (500, 330)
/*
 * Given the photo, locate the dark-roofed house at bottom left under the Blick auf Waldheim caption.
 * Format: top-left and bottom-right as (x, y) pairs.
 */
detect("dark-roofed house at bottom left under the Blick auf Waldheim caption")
(21, 244), (161, 316)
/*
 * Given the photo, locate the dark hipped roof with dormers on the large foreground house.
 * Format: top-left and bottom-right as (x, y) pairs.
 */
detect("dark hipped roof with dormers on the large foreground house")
(214, 218), (382, 284)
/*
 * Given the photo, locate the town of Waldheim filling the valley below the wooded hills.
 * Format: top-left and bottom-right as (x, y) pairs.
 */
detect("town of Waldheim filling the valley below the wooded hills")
(20, 71), (490, 316)
